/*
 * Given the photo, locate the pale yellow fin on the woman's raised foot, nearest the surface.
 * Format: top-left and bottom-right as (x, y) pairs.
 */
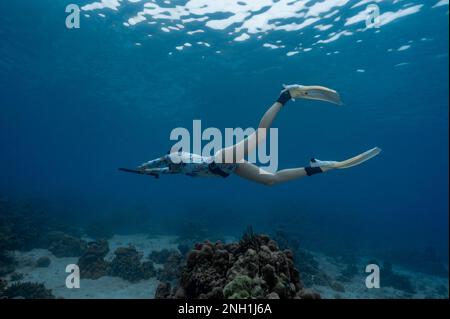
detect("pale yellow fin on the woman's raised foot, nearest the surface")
(283, 84), (343, 105)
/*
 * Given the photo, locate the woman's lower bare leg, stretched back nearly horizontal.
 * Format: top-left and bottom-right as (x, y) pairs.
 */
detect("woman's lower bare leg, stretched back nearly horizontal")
(234, 161), (323, 186)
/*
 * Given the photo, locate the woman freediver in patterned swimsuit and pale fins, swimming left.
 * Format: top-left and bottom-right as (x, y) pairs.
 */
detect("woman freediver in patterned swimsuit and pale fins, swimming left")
(120, 84), (381, 185)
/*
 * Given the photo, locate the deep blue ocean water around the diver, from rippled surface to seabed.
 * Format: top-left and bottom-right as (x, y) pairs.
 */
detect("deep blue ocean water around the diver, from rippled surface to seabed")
(0, 0), (449, 296)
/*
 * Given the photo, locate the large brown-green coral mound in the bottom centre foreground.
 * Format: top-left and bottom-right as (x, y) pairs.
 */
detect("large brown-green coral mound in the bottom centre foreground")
(159, 228), (320, 299)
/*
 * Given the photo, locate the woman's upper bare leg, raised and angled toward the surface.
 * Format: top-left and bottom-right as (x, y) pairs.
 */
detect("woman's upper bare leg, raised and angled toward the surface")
(214, 90), (291, 163)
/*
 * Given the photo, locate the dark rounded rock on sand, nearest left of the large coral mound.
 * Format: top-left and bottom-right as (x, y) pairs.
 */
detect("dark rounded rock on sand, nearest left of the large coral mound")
(109, 246), (155, 282)
